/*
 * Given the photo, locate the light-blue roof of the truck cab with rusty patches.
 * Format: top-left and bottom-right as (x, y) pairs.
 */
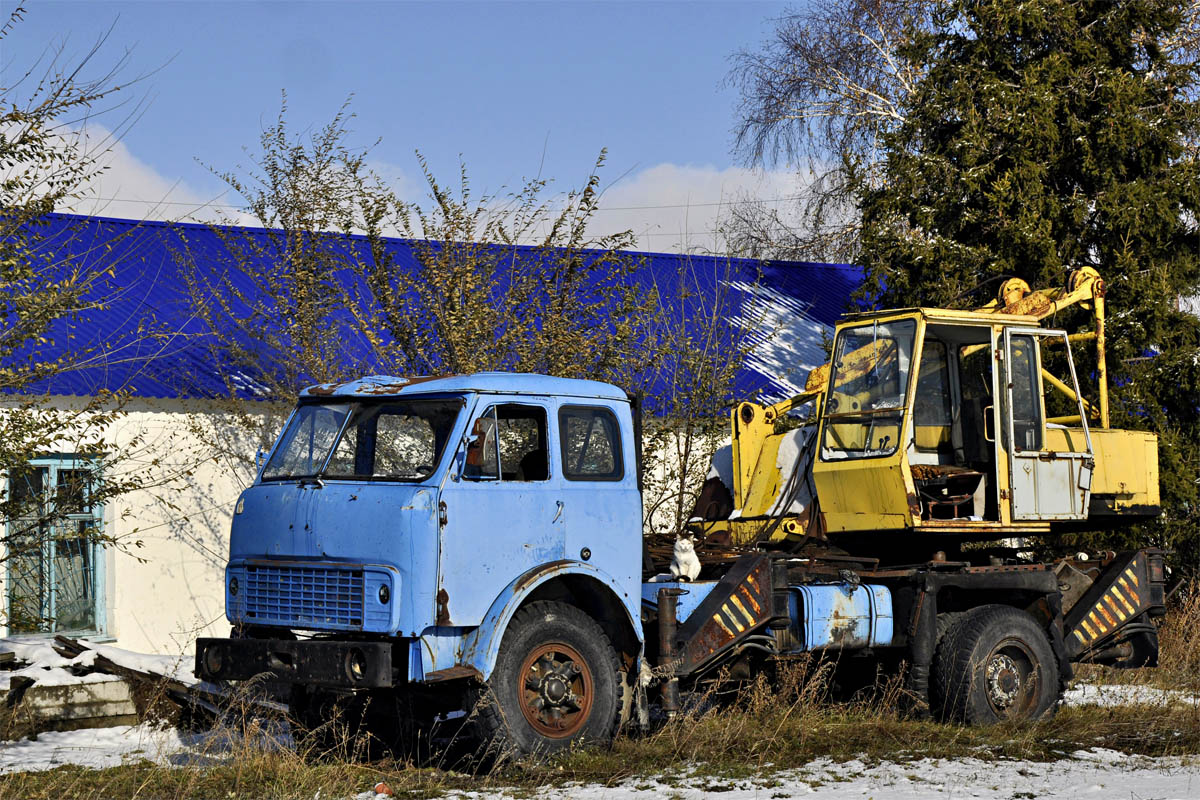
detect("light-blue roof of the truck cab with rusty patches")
(300, 372), (629, 401)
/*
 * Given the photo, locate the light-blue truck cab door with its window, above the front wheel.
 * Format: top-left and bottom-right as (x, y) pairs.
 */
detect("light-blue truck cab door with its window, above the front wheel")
(434, 397), (564, 626)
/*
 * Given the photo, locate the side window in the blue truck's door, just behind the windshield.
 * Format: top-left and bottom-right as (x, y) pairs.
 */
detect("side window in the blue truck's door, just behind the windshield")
(463, 403), (550, 481)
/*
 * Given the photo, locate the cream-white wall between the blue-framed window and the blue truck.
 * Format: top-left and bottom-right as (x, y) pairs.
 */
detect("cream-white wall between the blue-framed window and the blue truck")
(0, 398), (267, 654)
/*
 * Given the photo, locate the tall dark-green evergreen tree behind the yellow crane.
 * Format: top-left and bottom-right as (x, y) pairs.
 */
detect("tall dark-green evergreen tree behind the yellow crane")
(860, 0), (1200, 569)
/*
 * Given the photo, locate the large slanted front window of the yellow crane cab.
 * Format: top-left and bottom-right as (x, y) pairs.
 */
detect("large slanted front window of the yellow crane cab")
(821, 319), (917, 461)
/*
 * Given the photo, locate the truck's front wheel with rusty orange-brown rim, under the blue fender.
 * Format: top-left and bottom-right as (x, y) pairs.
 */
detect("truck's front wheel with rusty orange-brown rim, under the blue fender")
(475, 601), (620, 756)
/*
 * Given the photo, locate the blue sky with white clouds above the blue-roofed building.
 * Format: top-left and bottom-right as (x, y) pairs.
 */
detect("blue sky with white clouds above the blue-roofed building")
(7, 0), (806, 249)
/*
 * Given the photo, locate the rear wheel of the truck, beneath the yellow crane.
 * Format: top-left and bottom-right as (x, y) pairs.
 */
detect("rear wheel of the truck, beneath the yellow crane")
(932, 606), (1058, 724)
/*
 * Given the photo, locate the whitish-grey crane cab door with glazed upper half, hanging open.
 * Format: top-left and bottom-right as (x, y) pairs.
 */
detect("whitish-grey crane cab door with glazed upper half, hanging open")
(1002, 327), (1094, 522)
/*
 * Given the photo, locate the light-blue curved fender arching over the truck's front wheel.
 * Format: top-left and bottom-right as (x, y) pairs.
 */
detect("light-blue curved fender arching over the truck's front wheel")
(458, 560), (642, 680)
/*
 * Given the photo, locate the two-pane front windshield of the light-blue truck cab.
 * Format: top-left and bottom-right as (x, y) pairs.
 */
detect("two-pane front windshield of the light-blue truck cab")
(263, 399), (462, 481)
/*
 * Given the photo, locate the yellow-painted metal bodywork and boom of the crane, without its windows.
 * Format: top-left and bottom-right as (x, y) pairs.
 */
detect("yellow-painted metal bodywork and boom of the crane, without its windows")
(710, 267), (1158, 543)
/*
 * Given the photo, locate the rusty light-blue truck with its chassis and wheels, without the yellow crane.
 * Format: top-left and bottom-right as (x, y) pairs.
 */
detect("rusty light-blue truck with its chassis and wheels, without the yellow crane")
(196, 359), (1165, 752)
